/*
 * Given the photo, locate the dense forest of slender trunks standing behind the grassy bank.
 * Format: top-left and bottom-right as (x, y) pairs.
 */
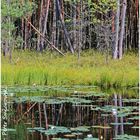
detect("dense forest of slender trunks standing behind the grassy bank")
(1, 0), (139, 59)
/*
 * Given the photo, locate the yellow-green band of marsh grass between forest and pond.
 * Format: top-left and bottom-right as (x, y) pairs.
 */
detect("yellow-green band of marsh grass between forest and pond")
(1, 51), (139, 88)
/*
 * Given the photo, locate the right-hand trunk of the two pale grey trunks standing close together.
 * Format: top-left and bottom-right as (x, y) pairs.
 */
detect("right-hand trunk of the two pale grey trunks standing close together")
(119, 0), (127, 59)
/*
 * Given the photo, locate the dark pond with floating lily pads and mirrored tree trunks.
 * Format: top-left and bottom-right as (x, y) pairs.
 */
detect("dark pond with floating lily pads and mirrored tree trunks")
(1, 86), (139, 140)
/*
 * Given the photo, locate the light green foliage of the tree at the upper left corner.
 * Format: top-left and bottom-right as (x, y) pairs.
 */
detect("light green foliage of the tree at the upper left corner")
(1, 0), (36, 47)
